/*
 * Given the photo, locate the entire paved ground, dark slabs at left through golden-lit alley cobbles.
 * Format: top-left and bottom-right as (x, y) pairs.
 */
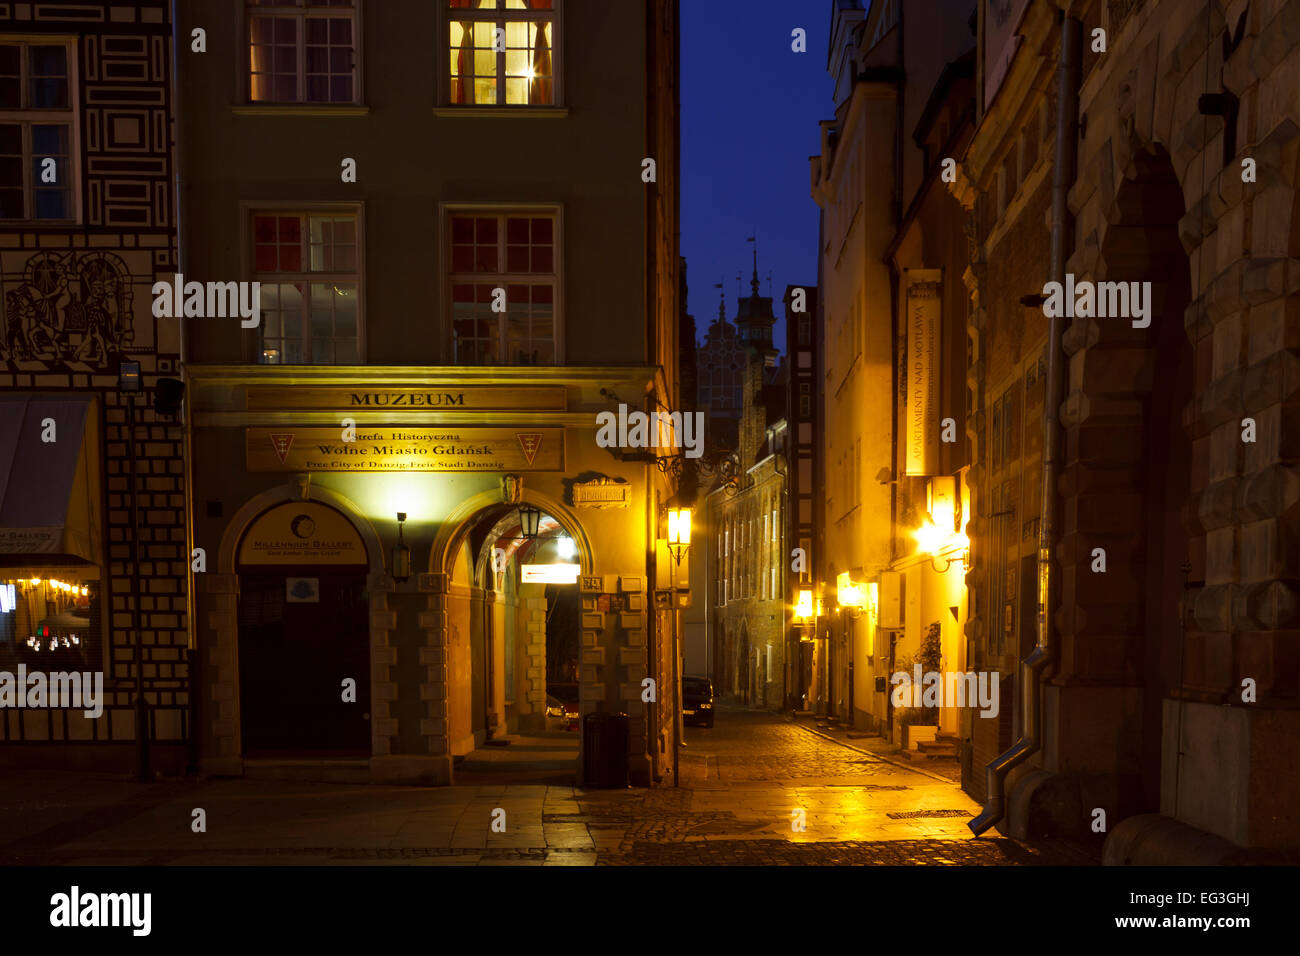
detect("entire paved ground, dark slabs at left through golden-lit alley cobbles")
(0, 709), (1097, 866)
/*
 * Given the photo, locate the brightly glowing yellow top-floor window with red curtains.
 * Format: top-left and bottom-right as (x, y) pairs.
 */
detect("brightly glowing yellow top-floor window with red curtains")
(447, 0), (560, 107)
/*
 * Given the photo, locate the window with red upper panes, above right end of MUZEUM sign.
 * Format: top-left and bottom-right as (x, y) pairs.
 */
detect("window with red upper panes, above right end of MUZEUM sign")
(450, 211), (559, 365)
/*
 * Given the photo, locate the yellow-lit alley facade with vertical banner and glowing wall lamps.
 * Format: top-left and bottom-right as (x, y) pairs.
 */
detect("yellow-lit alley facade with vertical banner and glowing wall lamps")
(811, 0), (974, 739)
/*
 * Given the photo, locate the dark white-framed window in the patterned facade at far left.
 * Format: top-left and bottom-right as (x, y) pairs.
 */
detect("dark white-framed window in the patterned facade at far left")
(0, 39), (77, 221)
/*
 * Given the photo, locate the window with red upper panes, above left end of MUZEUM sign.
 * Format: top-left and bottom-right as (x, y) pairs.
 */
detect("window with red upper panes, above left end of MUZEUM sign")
(252, 209), (361, 365)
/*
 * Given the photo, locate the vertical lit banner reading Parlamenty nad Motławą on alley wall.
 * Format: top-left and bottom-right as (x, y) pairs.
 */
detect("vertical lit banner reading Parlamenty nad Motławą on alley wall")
(902, 269), (944, 475)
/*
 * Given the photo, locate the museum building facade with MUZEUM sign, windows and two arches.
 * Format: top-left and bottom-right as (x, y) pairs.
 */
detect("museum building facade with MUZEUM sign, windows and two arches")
(181, 0), (683, 784)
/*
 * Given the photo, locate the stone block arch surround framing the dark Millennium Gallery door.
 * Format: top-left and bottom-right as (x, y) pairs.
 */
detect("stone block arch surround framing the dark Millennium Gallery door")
(195, 476), (397, 775)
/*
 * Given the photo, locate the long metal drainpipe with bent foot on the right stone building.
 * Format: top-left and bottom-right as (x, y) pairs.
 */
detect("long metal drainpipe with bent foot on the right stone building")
(967, 13), (1082, 836)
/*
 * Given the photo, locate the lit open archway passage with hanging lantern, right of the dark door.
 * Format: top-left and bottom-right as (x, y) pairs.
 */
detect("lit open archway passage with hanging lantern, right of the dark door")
(446, 505), (581, 786)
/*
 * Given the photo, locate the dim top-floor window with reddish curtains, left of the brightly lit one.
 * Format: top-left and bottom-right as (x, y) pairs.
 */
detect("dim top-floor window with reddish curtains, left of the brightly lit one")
(248, 0), (359, 104)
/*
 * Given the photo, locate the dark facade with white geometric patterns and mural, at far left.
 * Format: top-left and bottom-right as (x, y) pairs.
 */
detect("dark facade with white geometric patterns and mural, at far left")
(0, 0), (191, 773)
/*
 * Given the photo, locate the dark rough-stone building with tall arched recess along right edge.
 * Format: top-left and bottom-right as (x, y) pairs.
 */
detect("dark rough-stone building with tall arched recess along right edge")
(957, 1), (1300, 862)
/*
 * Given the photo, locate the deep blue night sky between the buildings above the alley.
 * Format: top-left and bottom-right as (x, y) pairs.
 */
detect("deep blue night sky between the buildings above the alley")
(681, 0), (833, 346)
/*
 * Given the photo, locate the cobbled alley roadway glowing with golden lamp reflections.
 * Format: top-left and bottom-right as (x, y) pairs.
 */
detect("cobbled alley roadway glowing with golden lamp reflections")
(577, 708), (1099, 866)
